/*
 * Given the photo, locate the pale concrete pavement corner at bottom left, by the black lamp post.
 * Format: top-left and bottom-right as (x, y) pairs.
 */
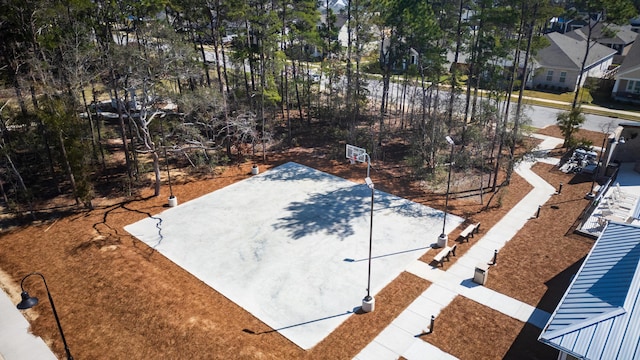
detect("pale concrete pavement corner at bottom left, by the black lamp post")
(0, 290), (56, 360)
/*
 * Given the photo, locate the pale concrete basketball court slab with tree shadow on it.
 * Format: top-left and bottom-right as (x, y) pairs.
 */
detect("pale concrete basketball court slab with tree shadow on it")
(125, 163), (463, 349)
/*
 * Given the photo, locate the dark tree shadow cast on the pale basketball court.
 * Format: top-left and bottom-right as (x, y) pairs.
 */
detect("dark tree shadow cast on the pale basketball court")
(273, 184), (442, 240)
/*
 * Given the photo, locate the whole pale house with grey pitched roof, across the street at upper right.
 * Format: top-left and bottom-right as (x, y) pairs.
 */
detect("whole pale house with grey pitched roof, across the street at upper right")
(528, 33), (616, 91)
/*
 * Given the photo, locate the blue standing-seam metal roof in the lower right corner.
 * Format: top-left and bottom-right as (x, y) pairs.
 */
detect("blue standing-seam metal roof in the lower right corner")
(538, 222), (640, 360)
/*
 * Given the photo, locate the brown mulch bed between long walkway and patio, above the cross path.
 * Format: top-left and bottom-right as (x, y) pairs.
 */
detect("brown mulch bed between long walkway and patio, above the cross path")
(487, 163), (593, 312)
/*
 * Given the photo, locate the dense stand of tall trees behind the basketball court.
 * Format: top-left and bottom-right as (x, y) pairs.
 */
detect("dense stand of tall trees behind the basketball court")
(0, 0), (639, 216)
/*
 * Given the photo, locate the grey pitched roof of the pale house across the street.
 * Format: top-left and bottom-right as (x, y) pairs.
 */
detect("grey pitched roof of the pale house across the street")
(536, 32), (616, 71)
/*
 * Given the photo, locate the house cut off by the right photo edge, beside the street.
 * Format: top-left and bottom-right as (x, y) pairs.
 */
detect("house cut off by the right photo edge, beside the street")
(611, 41), (640, 104)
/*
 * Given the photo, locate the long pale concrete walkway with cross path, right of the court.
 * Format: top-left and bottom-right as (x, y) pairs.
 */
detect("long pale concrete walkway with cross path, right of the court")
(354, 135), (562, 360)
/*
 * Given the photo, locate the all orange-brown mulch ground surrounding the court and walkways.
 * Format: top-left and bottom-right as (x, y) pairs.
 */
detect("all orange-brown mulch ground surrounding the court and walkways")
(0, 125), (601, 359)
